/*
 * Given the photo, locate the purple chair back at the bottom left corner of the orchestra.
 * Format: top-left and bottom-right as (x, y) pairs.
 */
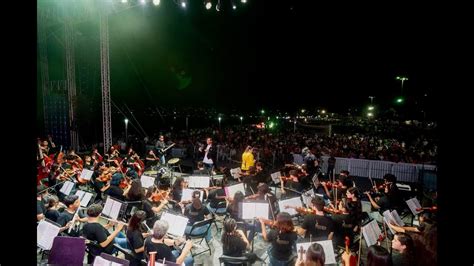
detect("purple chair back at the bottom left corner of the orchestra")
(48, 236), (86, 265)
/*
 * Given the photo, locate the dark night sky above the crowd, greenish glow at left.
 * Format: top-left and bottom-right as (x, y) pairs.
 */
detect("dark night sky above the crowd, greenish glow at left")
(39, 0), (439, 116)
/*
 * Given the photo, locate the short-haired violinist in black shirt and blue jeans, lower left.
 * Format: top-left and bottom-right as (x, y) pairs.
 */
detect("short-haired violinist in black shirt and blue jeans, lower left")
(82, 204), (127, 255)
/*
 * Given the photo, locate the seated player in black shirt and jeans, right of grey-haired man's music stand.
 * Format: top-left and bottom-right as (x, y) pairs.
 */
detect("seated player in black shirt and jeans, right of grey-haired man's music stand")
(184, 196), (212, 242)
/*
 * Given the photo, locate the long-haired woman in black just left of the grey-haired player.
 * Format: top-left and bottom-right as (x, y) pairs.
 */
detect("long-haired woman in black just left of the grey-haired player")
(127, 210), (150, 265)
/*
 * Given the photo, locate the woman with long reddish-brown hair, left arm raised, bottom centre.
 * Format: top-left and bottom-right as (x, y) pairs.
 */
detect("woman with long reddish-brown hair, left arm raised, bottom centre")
(259, 212), (298, 266)
